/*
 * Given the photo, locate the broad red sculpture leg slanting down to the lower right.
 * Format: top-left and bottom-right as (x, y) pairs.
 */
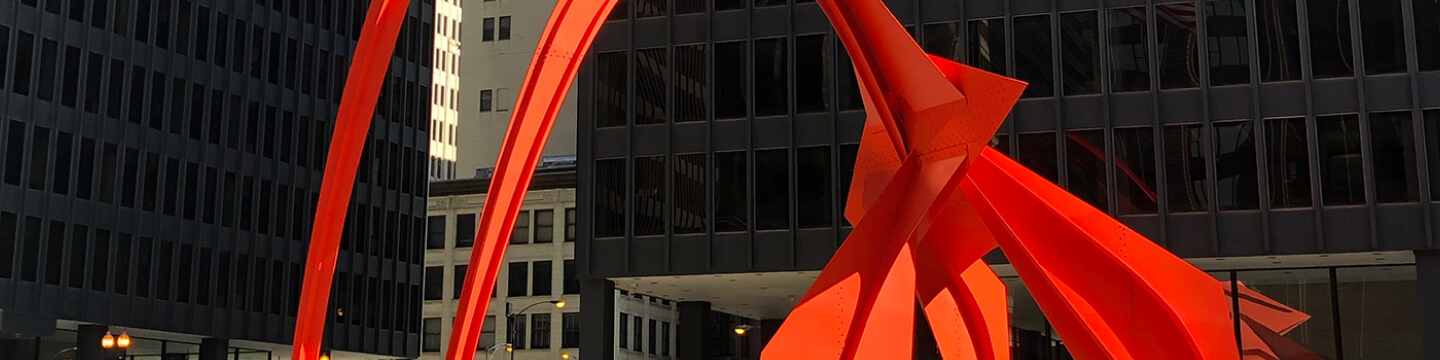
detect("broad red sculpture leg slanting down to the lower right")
(965, 150), (1238, 359)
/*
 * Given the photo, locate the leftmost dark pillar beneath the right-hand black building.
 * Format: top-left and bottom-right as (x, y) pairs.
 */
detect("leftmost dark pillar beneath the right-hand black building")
(580, 278), (615, 360)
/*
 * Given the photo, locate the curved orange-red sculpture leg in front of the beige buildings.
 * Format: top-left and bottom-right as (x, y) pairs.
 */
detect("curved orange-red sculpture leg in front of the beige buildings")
(446, 0), (616, 360)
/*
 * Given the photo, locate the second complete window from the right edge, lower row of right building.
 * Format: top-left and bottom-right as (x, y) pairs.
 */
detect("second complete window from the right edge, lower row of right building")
(1315, 114), (1365, 206)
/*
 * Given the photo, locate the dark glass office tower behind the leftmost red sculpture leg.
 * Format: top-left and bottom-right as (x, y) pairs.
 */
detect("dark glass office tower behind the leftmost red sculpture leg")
(0, 0), (433, 360)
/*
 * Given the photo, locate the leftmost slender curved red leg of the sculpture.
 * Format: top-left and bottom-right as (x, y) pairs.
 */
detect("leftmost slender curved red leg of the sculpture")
(292, 0), (410, 360)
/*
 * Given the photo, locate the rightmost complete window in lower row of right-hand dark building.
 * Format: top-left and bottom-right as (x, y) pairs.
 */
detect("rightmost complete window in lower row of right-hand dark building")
(1369, 111), (1420, 203)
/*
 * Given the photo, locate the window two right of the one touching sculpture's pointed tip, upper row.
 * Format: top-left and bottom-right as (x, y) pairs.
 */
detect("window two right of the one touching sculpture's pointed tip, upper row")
(1110, 6), (1151, 92)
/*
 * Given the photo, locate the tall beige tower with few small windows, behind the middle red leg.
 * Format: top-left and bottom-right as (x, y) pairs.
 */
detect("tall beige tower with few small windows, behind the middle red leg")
(456, 0), (576, 177)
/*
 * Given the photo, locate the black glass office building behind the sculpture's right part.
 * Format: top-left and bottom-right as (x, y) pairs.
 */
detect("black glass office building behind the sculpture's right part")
(577, 0), (1440, 360)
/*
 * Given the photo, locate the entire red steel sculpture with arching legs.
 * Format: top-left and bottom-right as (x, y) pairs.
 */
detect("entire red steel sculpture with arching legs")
(294, 0), (1240, 360)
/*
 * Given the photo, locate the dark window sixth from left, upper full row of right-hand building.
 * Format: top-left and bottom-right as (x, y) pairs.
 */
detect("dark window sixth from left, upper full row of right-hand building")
(795, 33), (832, 114)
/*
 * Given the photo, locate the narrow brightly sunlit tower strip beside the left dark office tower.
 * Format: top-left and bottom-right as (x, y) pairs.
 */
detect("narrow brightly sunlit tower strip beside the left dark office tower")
(429, 0), (468, 180)
